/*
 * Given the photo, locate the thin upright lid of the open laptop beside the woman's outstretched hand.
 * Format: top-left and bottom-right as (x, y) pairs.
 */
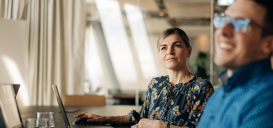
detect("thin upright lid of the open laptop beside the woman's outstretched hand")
(52, 85), (70, 128)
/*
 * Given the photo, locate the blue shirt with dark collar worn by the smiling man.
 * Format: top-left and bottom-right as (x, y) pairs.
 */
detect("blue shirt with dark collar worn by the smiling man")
(198, 58), (273, 128)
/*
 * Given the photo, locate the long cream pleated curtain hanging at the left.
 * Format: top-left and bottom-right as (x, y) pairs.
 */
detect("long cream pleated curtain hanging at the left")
(0, 0), (86, 105)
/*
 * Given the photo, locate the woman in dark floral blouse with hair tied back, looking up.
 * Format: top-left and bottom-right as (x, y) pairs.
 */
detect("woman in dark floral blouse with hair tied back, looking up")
(75, 28), (214, 128)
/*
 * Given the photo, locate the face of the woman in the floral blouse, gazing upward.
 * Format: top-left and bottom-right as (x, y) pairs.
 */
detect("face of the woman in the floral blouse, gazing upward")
(159, 34), (192, 70)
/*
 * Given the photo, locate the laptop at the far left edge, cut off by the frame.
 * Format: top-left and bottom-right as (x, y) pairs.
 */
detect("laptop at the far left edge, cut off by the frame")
(0, 84), (23, 128)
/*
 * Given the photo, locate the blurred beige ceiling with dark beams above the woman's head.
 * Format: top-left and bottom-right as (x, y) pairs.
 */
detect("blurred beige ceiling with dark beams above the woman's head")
(86, 0), (211, 37)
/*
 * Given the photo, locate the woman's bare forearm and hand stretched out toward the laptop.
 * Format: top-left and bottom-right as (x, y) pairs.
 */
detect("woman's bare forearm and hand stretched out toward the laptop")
(74, 112), (129, 124)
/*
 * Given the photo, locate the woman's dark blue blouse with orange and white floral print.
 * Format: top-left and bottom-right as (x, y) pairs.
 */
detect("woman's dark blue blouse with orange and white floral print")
(129, 75), (214, 128)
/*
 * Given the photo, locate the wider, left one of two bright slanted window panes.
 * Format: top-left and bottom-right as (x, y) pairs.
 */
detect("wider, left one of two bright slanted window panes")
(96, 0), (137, 89)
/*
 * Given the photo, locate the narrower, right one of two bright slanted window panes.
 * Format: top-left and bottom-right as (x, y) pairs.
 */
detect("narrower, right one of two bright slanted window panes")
(124, 4), (157, 79)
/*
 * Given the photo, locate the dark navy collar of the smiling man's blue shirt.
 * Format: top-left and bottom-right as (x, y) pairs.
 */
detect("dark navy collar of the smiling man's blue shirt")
(219, 58), (272, 91)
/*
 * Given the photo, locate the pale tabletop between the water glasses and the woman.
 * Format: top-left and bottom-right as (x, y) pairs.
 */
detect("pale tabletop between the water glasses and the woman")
(20, 105), (141, 128)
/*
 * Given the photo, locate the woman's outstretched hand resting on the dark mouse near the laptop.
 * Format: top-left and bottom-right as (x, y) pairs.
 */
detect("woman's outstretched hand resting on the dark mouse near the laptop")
(74, 112), (106, 123)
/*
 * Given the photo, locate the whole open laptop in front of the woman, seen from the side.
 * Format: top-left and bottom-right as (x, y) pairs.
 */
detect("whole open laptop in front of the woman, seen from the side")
(52, 85), (113, 128)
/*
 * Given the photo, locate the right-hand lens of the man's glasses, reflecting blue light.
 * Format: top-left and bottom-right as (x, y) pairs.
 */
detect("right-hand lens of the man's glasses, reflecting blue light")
(232, 18), (250, 33)
